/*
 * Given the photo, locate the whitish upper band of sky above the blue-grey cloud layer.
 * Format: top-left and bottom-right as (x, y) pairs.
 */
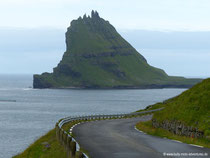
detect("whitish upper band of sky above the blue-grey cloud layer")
(0, 0), (210, 31)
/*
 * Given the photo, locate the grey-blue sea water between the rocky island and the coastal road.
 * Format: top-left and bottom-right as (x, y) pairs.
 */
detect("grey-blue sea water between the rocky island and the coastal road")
(0, 75), (186, 158)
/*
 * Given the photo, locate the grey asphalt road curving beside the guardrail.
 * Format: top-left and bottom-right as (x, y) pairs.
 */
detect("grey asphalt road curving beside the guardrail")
(73, 115), (210, 158)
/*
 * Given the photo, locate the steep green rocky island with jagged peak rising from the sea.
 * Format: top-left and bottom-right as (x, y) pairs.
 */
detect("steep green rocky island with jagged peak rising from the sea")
(33, 11), (200, 88)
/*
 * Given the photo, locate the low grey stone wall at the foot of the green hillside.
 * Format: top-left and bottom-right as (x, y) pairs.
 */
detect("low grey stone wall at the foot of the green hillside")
(152, 119), (204, 138)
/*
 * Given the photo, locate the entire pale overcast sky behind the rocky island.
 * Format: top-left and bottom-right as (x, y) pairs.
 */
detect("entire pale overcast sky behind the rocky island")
(0, 0), (210, 76)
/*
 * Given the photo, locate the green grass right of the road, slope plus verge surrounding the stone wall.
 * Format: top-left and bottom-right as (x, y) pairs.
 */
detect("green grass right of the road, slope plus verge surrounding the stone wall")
(137, 79), (210, 147)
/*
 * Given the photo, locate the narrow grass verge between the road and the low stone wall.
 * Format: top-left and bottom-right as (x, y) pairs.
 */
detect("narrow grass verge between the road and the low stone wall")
(136, 121), (210, 148)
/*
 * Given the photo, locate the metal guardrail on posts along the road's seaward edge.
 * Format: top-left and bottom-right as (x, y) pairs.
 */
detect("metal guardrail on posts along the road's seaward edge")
(56, 108), (163, 158)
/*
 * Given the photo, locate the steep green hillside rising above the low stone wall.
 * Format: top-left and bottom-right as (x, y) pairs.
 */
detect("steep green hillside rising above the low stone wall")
(148, 79), (210, 139)
